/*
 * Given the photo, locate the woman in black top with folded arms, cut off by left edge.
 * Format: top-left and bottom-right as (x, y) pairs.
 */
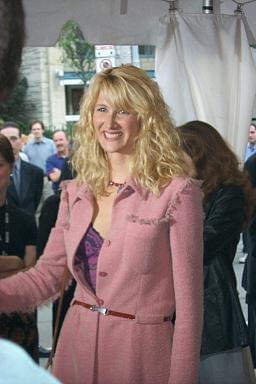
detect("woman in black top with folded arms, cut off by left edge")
(0, 134), (38, 361)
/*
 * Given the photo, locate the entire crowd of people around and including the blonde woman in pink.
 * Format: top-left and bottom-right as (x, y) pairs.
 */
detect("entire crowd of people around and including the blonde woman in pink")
(0, 0), (256, 384)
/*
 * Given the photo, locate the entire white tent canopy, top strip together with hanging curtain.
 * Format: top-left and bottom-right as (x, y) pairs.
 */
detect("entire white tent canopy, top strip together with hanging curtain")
(23, 0), (256, 160)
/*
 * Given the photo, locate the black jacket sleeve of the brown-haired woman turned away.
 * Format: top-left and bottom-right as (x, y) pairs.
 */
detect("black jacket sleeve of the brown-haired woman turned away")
(204, 186), (244, 263)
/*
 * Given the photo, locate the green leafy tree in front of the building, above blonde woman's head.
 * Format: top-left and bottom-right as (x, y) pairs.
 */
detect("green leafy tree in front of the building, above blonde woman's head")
(57, 20), (95, 84)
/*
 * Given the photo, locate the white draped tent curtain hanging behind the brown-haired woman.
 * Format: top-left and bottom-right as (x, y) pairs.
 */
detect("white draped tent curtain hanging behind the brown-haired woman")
(156, 12), (256, 160)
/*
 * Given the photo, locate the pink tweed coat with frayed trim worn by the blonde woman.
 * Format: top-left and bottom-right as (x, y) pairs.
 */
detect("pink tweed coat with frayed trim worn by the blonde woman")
(0, 178), (203, 384)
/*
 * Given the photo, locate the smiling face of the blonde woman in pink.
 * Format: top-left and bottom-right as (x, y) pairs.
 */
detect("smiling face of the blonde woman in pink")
(93, 93), (139, 155)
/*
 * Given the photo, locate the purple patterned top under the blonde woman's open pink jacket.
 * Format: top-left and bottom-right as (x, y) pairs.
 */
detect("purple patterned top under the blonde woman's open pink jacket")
(75, 224), (104, 292)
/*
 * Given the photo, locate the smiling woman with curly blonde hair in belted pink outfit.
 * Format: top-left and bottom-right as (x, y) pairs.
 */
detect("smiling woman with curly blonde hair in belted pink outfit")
(0, 65), (202, 384)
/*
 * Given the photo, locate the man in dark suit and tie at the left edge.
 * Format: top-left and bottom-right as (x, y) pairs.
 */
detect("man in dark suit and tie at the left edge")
(1, 121), (44, 215)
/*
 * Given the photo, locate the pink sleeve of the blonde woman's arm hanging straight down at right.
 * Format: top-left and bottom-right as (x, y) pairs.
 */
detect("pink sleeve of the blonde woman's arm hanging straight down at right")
(169, 182), (203, 384)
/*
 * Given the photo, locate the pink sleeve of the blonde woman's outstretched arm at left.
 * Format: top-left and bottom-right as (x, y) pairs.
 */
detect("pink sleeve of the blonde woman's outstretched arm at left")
(0, 184), (69, 313)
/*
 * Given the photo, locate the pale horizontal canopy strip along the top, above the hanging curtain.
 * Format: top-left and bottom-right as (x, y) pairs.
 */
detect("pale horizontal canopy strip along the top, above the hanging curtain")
(23, 0), (256, 47)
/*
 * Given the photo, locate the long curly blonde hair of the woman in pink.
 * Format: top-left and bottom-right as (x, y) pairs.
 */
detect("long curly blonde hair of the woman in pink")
(72, 64), (187, 195)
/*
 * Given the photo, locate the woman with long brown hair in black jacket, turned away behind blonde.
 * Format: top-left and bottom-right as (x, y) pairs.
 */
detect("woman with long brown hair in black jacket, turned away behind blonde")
(178, 121), (253, 384)
